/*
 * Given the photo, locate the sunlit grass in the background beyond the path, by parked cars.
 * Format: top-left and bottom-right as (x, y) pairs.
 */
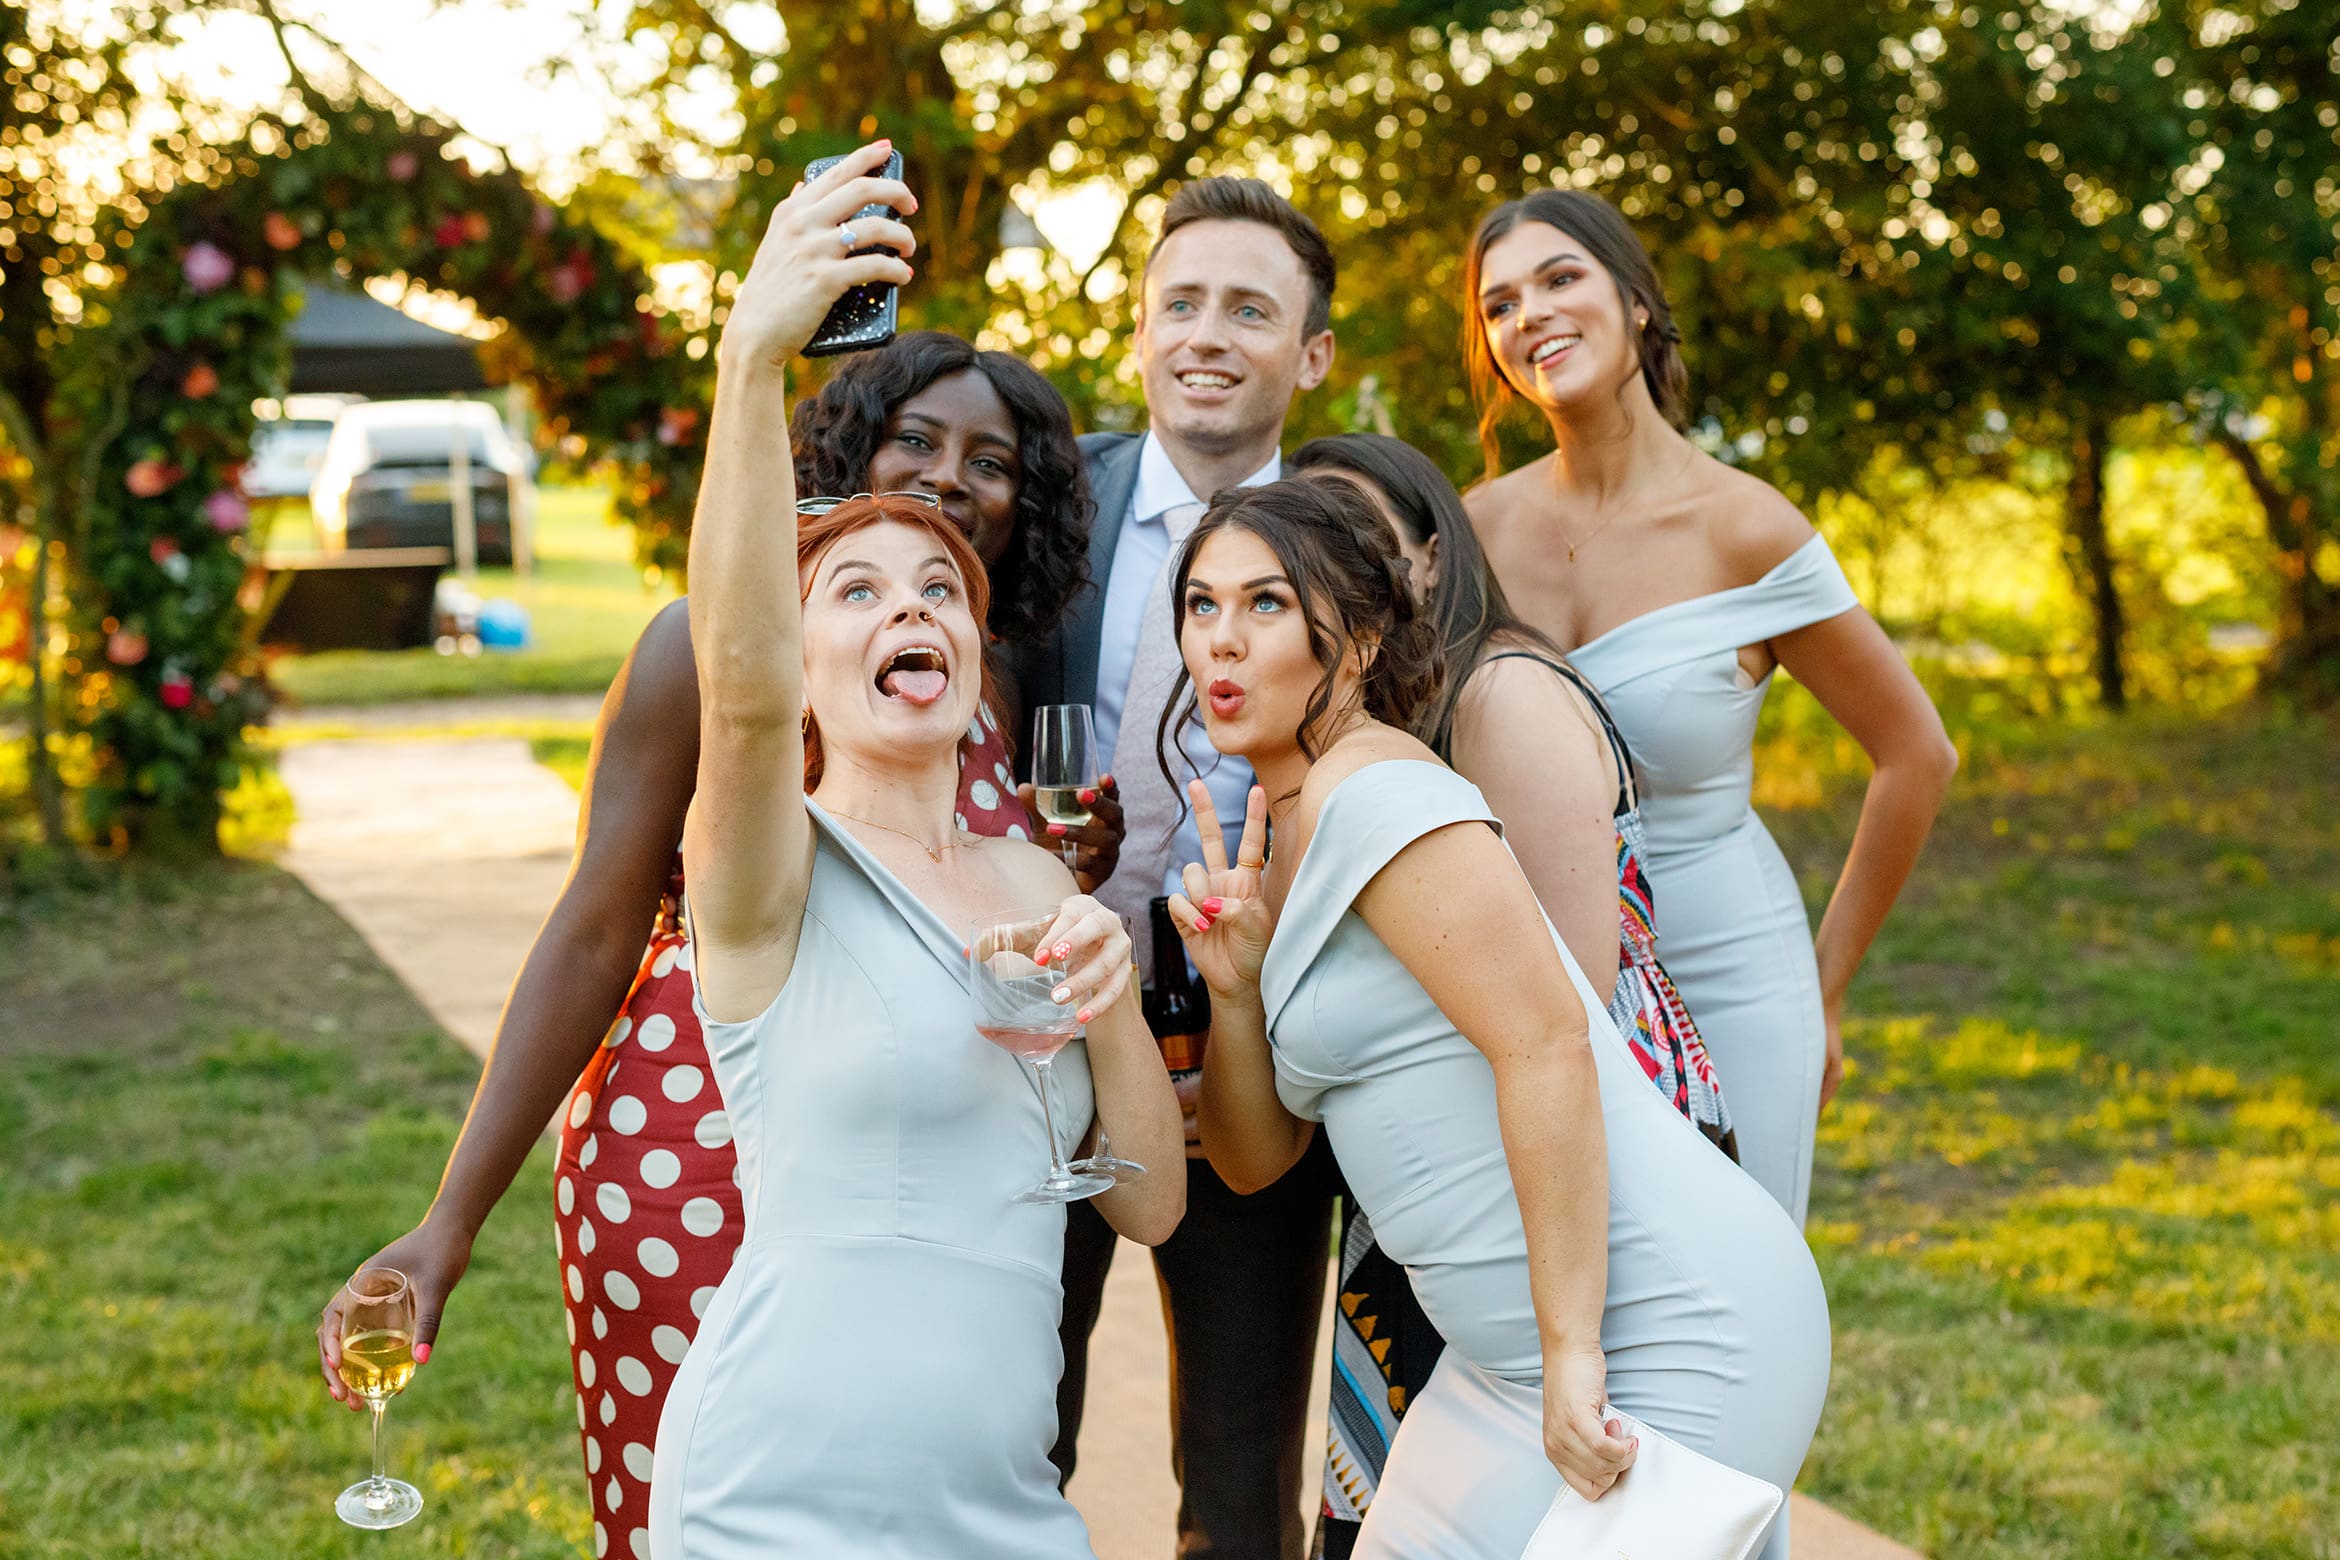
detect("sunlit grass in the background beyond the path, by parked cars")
(269, 486), (674, 704)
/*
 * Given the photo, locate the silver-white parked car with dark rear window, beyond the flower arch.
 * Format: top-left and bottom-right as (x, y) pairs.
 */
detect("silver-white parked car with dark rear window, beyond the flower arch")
(309, 400), (531, 564)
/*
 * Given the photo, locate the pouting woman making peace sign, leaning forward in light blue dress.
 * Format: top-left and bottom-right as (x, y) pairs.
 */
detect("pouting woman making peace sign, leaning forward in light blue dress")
(1172, 479), (1830, 1560)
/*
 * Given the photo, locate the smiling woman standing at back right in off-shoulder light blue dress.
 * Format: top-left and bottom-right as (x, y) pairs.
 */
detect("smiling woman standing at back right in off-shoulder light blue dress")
(1463, 189), (1959, 1223)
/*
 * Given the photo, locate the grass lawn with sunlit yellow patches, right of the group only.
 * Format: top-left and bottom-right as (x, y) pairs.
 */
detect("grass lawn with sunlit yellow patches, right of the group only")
(1769, 699), (2340, 1560)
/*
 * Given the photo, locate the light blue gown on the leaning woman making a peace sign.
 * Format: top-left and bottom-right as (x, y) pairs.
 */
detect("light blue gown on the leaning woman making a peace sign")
(1261, 760), (1830, 1560)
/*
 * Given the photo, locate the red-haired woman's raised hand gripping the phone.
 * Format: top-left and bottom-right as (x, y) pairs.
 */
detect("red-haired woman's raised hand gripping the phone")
(721, 140), (917, 367)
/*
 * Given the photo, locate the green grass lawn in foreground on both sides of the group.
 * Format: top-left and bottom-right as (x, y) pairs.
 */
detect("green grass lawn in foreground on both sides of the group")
(0, 690), (2340, 1560)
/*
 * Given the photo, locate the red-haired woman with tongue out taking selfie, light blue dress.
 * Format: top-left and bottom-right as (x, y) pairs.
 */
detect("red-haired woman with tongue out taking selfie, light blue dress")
(650, 145), (1184, 1560)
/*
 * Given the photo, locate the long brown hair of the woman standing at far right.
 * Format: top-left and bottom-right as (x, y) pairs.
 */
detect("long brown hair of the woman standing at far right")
(1463, 189), (1689, 482)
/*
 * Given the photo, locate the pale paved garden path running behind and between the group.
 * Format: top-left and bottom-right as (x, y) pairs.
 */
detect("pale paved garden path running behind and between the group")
(283, 725), (1916, 1560)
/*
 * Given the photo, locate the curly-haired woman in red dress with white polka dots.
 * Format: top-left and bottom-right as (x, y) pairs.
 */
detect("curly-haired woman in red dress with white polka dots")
(318, 332), (1121, 1555)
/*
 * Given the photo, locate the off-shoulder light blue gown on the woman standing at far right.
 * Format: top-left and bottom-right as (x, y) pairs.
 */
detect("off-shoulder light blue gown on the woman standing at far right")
(1568, 536), (1860, 1226)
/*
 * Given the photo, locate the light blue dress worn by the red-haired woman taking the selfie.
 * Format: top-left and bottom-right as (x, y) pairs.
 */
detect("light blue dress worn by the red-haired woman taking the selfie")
(651, 802), (1093, 1560)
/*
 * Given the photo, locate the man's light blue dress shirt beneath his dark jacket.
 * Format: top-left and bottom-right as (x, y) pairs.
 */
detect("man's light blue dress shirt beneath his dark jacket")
(1095, 433), (1285, 902)
